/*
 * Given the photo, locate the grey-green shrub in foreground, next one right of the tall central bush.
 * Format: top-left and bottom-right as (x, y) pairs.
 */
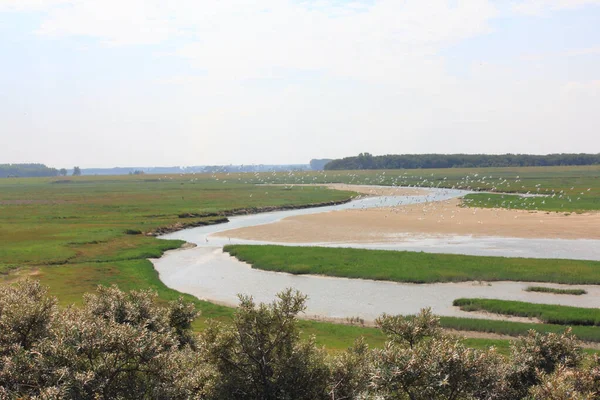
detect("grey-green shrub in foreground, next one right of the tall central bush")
(371, 309), (502, 400)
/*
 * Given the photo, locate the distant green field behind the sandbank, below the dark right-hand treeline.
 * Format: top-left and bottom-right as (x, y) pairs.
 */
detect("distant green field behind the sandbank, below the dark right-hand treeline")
(239, 165), (600, 212)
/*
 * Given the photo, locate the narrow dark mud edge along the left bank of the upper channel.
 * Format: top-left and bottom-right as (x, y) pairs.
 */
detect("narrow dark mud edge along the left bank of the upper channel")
(146, 198), (352, 236)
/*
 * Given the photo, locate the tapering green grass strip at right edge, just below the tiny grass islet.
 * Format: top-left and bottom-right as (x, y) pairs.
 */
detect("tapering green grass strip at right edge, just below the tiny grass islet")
(453, 298), (600, 326)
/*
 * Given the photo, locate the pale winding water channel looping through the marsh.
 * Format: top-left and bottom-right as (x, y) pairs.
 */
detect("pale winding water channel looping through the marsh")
(152, 189), (600, 321)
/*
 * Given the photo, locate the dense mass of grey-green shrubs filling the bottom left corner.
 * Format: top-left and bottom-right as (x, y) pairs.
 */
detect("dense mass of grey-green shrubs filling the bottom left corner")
(0, 281), (211, 399)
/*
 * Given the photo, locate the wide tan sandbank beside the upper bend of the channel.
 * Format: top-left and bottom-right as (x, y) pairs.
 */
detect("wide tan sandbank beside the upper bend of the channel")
(216, 197), (600, 243)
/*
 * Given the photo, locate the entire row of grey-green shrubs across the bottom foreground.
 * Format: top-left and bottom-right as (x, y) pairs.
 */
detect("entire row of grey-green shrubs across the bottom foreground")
(0, 281), (600, 400)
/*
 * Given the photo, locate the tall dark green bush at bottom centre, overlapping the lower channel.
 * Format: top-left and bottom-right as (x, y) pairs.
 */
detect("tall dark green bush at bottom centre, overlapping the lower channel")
(200, 289), (328, 400)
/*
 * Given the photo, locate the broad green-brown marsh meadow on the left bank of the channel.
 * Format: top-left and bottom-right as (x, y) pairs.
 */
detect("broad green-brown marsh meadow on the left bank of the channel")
(0, 174), (352, 304)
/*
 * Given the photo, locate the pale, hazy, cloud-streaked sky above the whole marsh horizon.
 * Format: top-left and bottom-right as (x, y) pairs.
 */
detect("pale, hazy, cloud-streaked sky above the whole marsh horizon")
(0, 0), (600, 168)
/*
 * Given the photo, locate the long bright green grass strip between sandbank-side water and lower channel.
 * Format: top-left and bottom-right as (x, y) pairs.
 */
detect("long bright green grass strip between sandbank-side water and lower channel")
(224, 245), (600, 284)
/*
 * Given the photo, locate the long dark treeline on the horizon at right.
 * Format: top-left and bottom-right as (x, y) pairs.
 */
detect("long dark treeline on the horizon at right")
(325, 153), (600, 170)
